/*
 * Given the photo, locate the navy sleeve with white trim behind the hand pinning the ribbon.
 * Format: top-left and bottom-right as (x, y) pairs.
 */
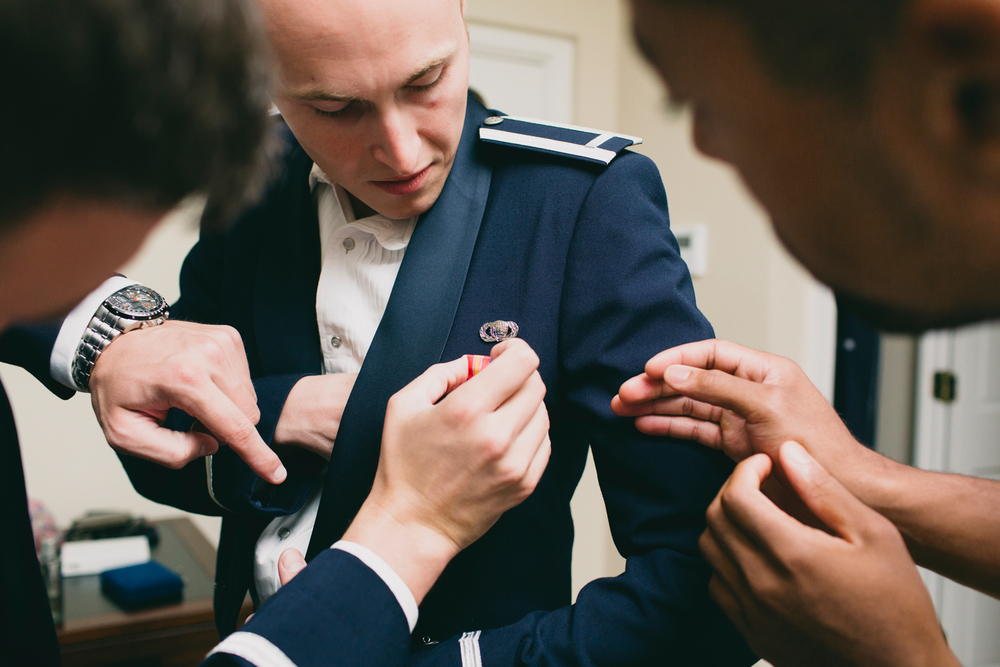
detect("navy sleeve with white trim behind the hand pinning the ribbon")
(202, 549), (410, 667)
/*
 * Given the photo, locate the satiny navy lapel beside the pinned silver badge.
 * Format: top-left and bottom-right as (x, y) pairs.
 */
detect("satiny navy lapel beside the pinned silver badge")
(307, 98), (492, 559)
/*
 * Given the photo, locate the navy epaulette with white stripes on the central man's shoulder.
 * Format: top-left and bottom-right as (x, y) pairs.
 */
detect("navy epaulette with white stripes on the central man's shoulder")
(479, 116), (642, 165)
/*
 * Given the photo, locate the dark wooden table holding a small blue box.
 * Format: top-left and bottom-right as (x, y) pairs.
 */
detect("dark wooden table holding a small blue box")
(57, 519), (252, 667)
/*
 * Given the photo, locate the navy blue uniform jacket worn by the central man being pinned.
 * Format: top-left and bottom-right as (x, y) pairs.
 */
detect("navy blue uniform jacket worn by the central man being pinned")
(11, 99), (753, 665)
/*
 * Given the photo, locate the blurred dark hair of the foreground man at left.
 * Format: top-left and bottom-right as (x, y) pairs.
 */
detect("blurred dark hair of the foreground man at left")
(0, 0), (272, 225)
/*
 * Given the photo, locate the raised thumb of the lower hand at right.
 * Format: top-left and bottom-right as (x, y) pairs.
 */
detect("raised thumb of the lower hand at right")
(778, 441), (875, 541)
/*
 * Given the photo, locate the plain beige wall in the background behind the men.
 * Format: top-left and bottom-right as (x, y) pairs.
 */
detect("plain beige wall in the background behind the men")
(0, 0), (840, 612)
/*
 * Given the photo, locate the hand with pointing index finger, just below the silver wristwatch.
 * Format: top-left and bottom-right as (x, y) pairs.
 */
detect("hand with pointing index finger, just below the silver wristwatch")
(90, 321), (287, 484)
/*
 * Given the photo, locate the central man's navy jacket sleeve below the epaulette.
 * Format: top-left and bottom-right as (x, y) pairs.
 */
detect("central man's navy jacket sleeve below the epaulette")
(417, 153), (755, 665)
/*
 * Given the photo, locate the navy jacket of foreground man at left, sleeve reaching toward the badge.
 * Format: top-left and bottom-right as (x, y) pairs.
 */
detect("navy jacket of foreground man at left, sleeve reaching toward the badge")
(0, 344), (410, 667)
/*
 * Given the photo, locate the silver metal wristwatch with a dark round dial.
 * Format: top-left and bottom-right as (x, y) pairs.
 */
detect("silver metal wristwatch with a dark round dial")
(73, 285), (169, 391)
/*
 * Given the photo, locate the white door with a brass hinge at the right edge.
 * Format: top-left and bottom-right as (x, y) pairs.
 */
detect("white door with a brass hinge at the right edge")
(914, 323), (1000, 667)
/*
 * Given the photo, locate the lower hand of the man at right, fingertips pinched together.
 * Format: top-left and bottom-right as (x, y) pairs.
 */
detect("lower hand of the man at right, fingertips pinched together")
(699, 442), (958, 667)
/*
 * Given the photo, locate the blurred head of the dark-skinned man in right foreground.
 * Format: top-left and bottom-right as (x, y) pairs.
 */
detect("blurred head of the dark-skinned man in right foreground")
(632, 0), (1000, 328)
